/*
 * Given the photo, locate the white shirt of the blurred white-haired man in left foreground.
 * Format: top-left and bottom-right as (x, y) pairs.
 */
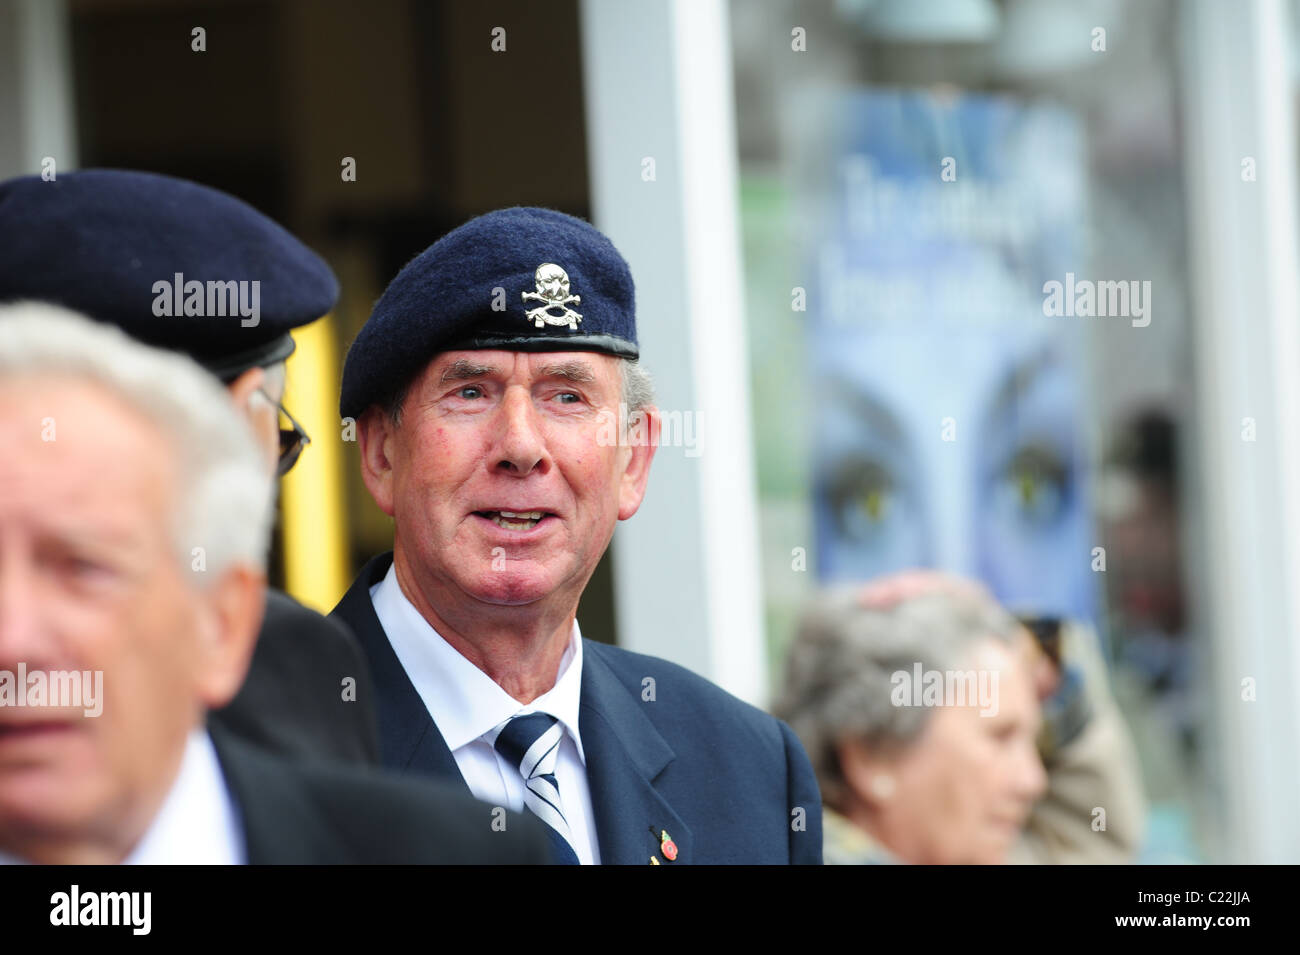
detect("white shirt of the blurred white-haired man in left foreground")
(0, 729), (246, 865)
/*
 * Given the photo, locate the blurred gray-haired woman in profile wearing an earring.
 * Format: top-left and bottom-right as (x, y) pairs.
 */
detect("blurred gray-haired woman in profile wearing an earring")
(776, 578), (1047, 863)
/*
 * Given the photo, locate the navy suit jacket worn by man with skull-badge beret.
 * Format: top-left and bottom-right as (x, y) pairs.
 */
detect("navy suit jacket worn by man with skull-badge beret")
(332, 554), (822, 865)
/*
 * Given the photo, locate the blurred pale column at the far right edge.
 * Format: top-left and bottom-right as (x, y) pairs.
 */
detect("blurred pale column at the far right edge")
(1180, 0), (1300, 863)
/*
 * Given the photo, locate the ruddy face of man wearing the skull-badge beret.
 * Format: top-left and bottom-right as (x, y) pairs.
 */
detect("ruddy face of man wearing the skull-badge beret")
(361, 351), (654, 607)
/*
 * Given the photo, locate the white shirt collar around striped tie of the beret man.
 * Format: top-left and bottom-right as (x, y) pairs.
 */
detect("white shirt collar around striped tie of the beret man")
(371, 564), (586, 764)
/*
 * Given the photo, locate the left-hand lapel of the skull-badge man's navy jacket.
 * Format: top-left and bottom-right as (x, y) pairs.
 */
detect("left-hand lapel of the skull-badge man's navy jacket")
(330, 552), (469, 793)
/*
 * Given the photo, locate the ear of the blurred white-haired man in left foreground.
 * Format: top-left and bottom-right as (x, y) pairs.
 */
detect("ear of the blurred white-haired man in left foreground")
(195, 564), (267, 709)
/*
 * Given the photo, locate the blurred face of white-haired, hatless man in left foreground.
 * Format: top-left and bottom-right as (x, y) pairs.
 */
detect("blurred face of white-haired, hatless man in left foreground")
(0, 377), (236, 854)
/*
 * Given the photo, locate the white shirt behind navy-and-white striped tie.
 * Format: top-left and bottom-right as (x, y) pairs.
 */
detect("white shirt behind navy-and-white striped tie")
(371, 565), (601, 865)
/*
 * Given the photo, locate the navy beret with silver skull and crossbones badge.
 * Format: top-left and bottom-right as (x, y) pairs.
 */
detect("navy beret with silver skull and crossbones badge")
(339, 207), (638, 418)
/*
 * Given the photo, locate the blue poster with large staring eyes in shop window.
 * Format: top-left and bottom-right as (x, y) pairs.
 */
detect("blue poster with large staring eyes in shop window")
(809, 92), (1095, 618)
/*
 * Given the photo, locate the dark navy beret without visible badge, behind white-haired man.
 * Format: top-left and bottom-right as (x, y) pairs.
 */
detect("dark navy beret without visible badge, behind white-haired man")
(0, 169), (338, 379)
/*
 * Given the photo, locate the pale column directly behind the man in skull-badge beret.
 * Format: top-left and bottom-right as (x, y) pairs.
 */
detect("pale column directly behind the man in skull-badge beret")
(581, 0), (767, 703)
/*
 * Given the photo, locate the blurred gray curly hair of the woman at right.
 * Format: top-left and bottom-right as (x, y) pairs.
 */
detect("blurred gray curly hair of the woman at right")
(774, 586), (1021, 807)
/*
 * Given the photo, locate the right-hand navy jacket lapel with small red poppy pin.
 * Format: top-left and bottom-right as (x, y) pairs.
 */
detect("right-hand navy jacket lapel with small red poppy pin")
(579, 641), (694, 865)
